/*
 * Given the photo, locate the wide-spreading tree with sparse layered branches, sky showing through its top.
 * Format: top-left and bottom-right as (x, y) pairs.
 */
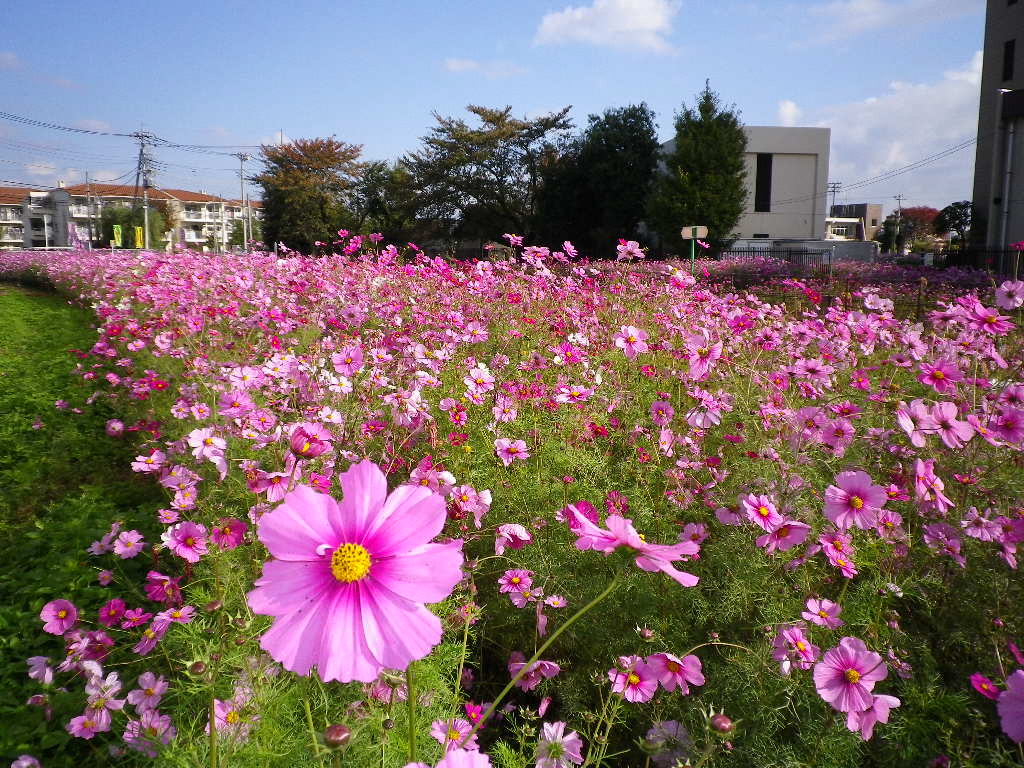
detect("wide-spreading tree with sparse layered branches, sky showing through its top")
(402, 104), (571, 238)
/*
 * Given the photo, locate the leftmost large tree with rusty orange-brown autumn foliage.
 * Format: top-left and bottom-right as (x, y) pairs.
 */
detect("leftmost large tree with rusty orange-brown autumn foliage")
(253, 138), (364, 253)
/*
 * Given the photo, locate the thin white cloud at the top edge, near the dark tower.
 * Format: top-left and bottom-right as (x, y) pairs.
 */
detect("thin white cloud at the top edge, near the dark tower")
(804, 0), (985, 42)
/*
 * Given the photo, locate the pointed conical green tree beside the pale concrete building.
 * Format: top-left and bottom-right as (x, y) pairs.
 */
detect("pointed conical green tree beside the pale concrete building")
(647, 84), (746, 250)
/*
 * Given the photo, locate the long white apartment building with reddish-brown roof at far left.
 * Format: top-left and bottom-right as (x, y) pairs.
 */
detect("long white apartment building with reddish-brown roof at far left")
(0, 183), (260, 251)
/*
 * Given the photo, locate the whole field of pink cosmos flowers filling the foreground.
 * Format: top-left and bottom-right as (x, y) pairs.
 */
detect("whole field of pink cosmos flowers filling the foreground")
(0, 243), (1024, 768)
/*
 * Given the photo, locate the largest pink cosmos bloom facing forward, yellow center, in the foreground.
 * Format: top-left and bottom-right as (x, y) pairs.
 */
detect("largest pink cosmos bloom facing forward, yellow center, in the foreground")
(249, 460), (463, 683)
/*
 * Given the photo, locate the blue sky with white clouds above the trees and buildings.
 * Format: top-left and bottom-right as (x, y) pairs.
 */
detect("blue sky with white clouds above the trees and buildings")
(0, 0), (984, 217)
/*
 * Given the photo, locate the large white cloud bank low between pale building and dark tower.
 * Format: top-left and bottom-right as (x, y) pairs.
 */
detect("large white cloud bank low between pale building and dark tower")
(811, 51), (982, 208)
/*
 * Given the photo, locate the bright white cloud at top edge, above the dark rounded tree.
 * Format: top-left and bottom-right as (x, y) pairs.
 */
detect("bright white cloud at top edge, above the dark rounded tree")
(534, 0), (680, 53)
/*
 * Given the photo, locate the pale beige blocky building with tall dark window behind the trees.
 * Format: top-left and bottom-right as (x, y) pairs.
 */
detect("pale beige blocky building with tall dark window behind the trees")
(736, 126), (831, 239)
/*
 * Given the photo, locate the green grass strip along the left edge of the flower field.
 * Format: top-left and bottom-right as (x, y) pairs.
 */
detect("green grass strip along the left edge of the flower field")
(0, 284), (161, 766)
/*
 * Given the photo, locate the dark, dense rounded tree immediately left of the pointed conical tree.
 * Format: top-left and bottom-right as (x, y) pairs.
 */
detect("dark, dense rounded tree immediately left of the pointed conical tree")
(537, 103), (658, 255)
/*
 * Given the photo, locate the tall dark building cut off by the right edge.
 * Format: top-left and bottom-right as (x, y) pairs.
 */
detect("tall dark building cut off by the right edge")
(971, 0), (1024, 249)
